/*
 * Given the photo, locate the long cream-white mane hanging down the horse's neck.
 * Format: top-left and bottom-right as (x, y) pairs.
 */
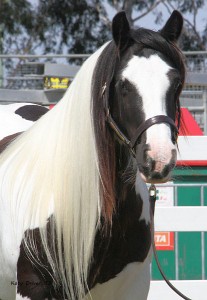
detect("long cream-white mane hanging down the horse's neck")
(0, 45), (108, 299)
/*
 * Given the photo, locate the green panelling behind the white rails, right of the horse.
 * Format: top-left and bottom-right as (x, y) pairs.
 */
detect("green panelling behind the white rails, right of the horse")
(152, 167), (207, 280)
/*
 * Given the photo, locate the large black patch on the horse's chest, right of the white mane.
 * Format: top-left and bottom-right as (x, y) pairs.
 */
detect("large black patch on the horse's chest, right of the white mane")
(89, 193), (151, 287)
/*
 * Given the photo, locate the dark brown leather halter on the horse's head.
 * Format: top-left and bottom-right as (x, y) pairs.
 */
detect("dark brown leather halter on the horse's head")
(102, 83), (179, 157)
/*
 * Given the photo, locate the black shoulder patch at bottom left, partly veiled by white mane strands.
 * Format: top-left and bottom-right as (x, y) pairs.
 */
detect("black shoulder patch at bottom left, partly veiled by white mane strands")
(17, 217), (61, 300)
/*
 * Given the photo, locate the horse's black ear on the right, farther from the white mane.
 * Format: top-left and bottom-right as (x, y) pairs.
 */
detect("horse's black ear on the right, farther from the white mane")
(160, 10), (183, 42)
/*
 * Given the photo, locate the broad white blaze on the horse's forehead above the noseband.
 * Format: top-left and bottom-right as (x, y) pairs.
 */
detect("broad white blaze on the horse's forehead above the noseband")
(122, 54), (172, 118)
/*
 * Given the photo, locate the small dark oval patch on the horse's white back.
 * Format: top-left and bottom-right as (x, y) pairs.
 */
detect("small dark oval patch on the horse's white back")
(15, 105), (49, 122)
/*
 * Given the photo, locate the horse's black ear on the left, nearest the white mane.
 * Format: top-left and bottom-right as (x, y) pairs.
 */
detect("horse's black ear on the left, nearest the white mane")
(112, 11), (130, 50)
